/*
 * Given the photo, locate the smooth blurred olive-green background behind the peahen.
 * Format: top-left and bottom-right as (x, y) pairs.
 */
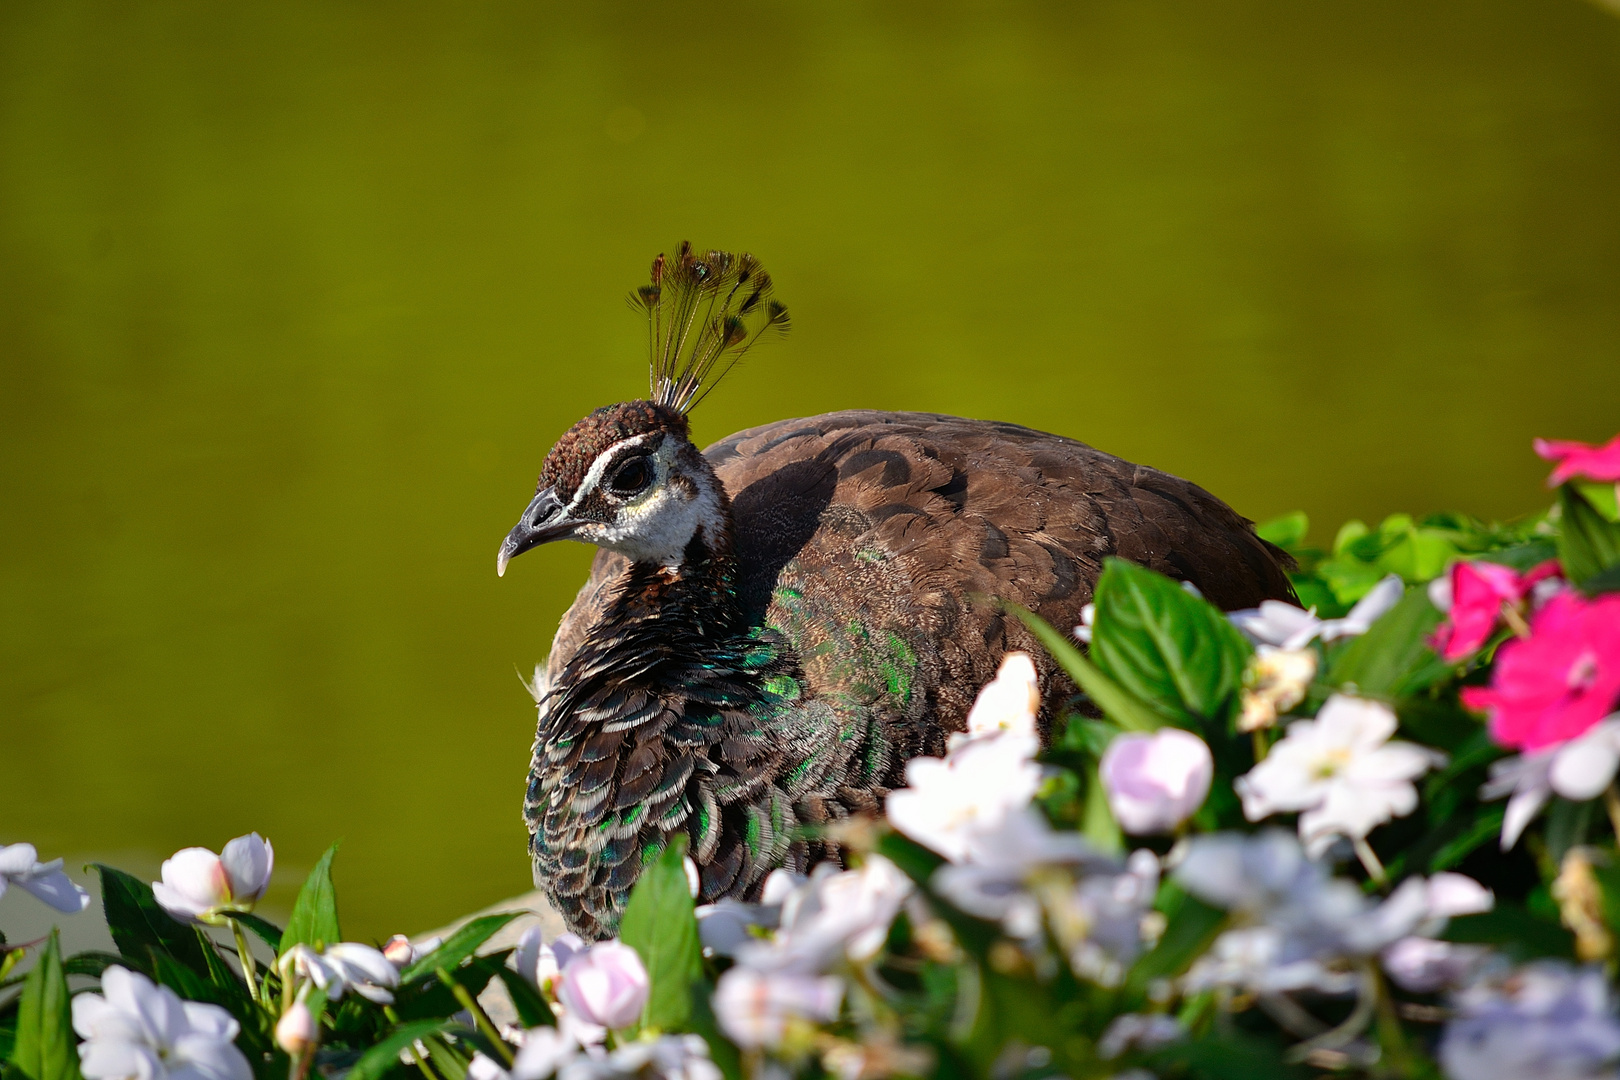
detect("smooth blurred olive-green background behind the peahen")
(0, 0), (1620, 939)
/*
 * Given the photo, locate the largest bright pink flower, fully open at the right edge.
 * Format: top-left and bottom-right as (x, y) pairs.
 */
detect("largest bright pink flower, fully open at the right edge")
(1463, 593), (1620, 751)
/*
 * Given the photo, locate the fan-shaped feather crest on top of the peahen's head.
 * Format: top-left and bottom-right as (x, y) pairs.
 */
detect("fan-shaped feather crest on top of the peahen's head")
(629, 241), (787, 413)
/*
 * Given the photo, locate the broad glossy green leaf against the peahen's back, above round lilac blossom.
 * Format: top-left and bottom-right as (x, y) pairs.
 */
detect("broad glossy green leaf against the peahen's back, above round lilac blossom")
(1090, 559), (1251, 724)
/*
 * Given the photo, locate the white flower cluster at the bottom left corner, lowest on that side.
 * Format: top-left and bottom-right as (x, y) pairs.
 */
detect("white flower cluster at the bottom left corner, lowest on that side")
(73, 967), (253, 1080)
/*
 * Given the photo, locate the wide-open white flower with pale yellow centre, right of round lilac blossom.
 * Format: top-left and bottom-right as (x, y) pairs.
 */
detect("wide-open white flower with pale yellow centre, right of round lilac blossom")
(1236, 695), (1445, 855)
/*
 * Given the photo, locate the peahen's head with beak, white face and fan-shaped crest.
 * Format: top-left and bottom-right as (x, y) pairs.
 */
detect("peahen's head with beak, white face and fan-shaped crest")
(496, 243), (787, 575)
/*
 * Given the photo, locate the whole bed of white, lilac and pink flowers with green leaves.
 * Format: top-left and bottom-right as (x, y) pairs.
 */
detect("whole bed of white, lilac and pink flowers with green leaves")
(9, 442), (1620, 1080)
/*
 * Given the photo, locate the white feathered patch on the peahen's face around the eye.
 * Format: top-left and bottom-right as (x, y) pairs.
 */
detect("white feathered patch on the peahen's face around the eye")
(569, 432), (723, 570)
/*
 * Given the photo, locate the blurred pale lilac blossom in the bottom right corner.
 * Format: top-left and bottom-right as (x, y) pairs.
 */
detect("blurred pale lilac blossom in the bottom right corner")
(1439, 960), (1620, 1080)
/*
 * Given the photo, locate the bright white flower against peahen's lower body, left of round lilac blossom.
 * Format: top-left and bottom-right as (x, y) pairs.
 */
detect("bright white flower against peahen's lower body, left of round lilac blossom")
(886, 732), (1040, 861)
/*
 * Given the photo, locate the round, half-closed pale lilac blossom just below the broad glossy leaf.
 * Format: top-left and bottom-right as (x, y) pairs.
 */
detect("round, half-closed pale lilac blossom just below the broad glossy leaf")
(1098, 727), (1215, 836)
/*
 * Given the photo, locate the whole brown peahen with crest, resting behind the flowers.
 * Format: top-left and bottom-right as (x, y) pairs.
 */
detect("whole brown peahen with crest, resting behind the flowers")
(499, 246), (1293, 938)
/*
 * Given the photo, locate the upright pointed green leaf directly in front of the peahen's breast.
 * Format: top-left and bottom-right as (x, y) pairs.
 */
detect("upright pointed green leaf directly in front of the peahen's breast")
(619, 832), (703, 1030)
